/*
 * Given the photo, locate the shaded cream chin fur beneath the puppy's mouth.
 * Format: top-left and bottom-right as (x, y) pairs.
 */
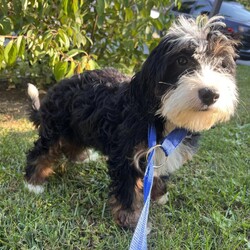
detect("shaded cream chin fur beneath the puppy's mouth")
(166, 105), (231, 132)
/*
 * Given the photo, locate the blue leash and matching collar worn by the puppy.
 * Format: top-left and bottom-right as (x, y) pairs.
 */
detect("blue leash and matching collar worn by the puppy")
(129, 126), (188, 250)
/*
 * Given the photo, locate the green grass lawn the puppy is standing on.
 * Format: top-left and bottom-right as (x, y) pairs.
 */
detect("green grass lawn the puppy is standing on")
(0, 66), (250, 250)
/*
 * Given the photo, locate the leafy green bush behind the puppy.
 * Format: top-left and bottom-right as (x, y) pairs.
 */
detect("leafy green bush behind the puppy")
(0, 0), (174, 86)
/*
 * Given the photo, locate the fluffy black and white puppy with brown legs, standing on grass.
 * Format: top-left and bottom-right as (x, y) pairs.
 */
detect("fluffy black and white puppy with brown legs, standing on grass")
(25, 17), (238, 228)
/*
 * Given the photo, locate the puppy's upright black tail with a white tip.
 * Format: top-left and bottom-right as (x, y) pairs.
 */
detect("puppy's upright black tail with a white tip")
(27, 83), (40, 127)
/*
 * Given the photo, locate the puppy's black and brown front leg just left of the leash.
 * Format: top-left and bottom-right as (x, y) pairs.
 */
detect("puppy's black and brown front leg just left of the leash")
(109, 157), (143, 228)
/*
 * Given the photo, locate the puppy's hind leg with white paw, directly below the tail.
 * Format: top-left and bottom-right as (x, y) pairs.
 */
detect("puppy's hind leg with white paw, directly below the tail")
(25, 137), (61, 193)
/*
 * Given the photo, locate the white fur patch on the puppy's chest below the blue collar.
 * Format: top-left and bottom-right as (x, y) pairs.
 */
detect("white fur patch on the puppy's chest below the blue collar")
(154, 143), (195, 176)
